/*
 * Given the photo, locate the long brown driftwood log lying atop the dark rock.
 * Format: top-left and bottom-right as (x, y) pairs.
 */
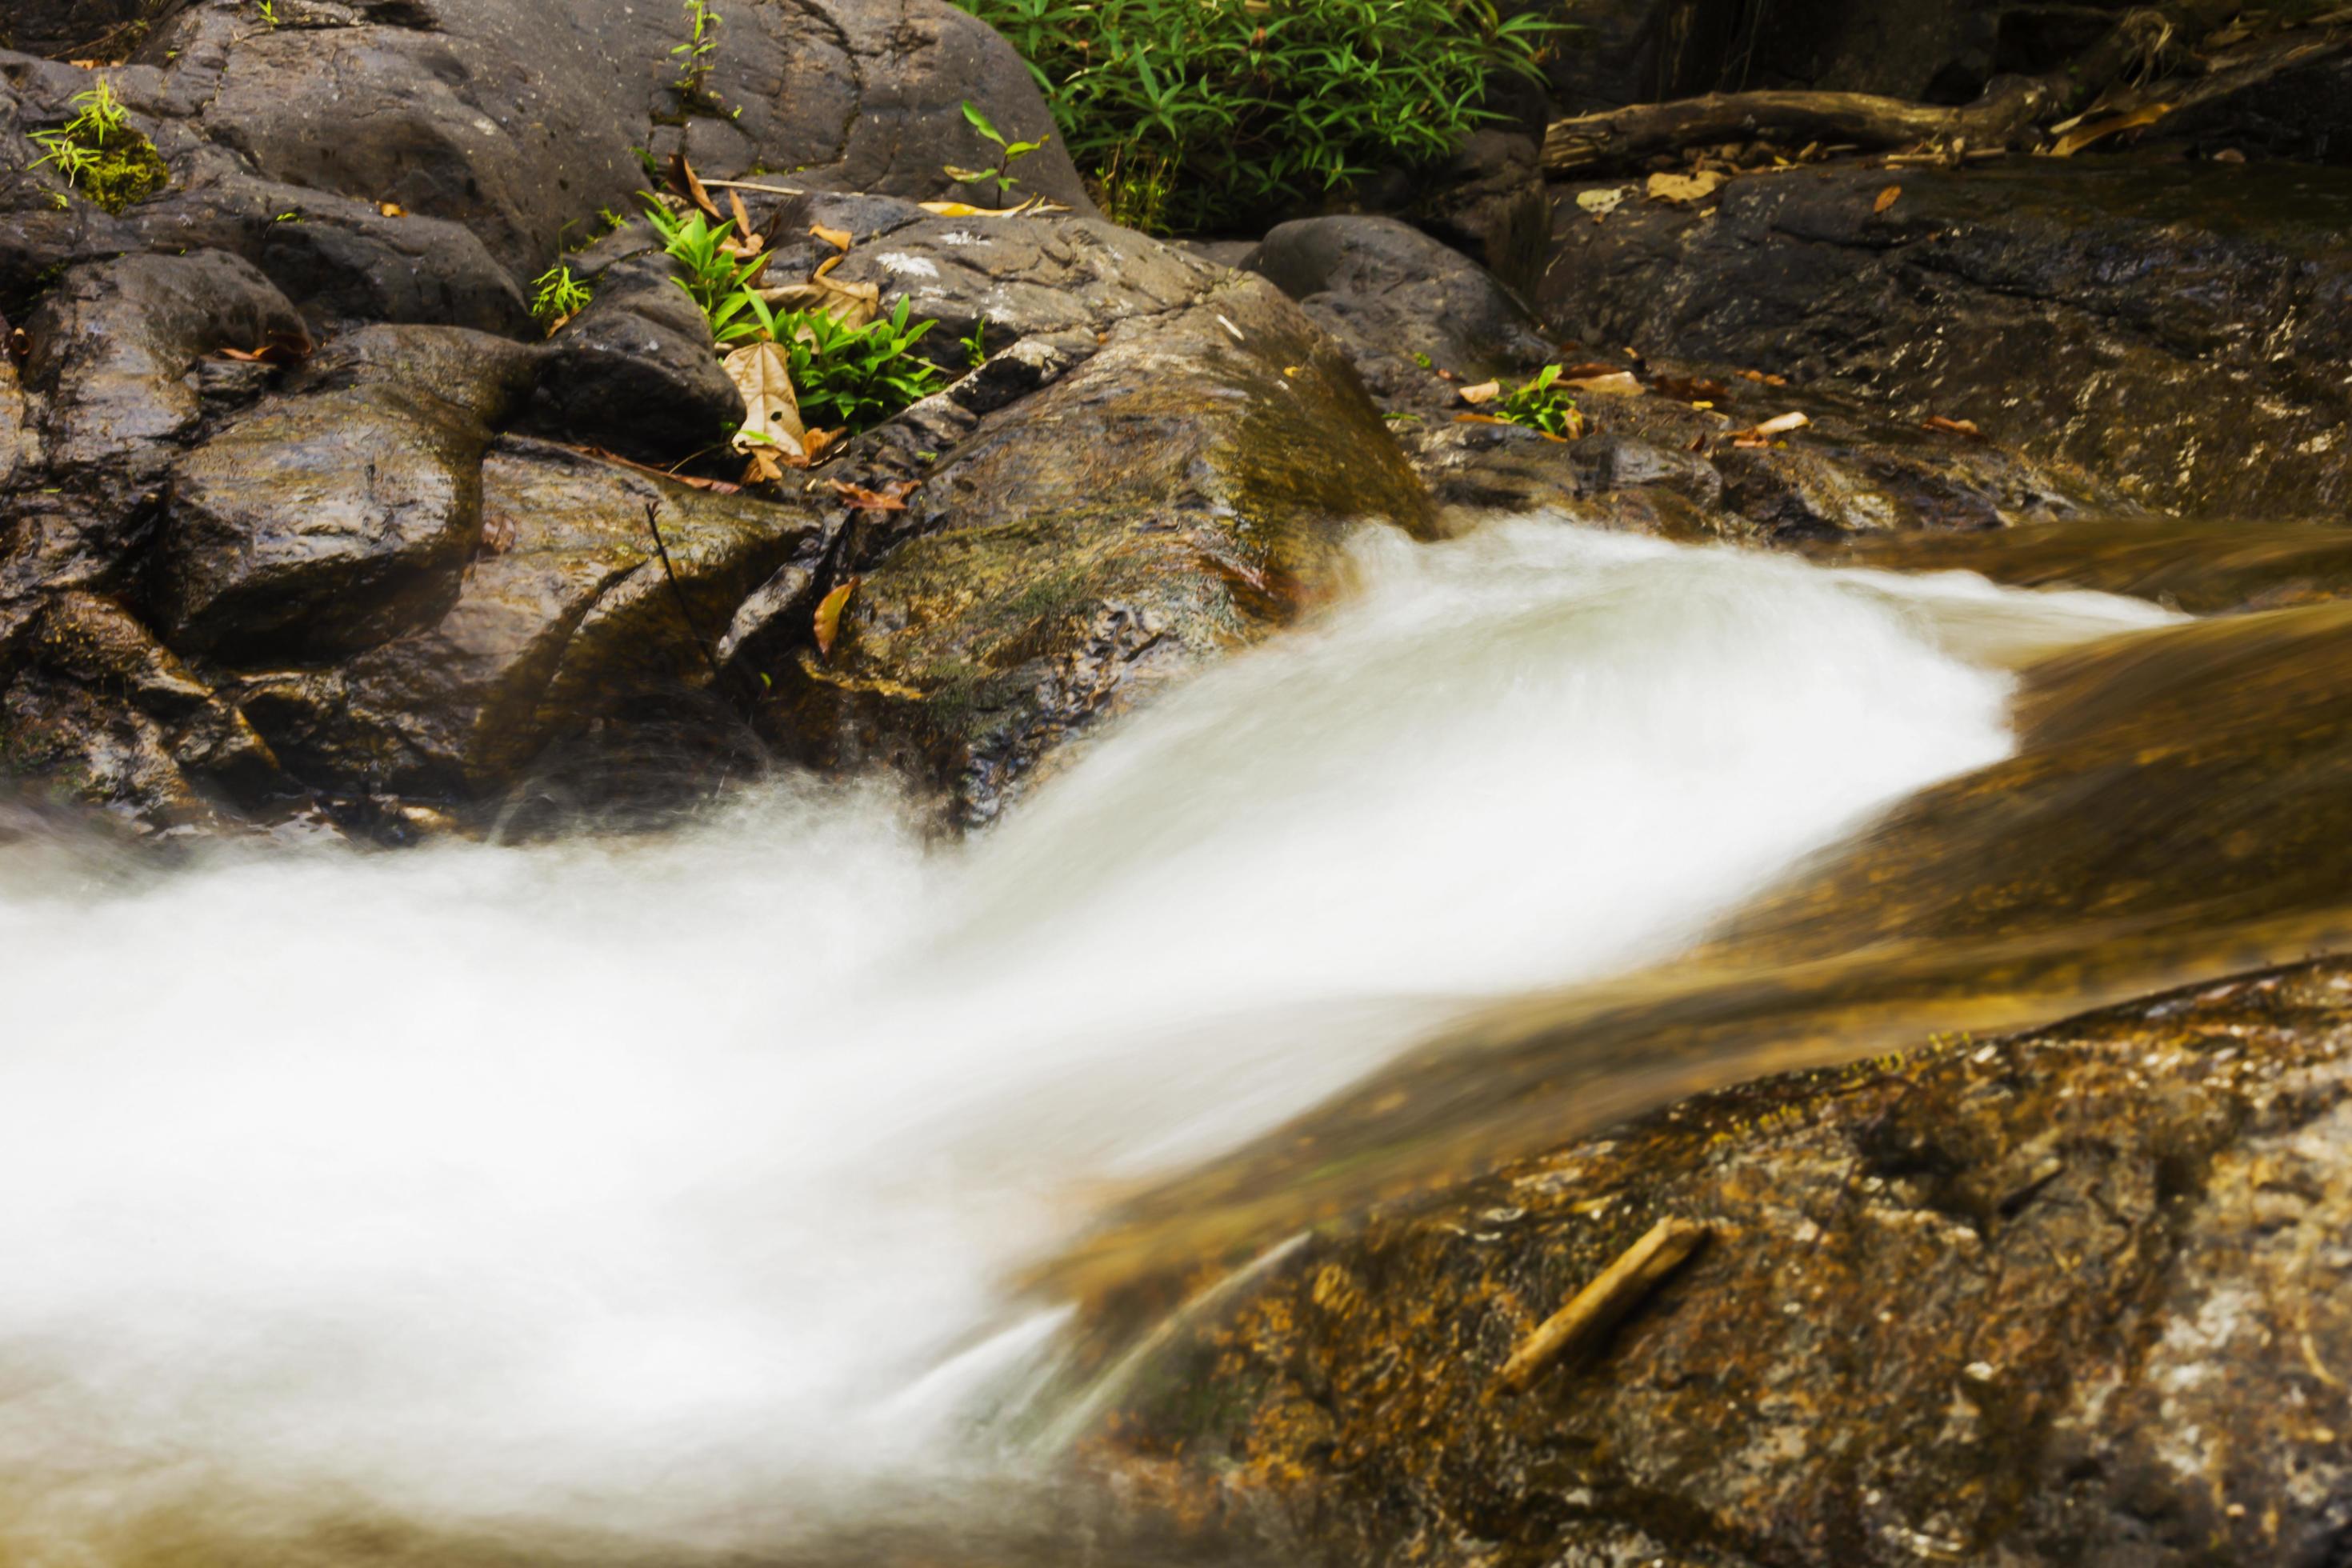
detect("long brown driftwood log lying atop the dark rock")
(1543, 12), (2352, 176)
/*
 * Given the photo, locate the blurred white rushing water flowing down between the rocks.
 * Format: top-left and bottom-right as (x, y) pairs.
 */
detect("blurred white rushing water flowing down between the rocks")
(0, 519), (2162, 1563)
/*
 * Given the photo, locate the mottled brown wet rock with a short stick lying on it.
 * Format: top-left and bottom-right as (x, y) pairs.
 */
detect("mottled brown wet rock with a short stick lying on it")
(1098, 962), (2352, 1568)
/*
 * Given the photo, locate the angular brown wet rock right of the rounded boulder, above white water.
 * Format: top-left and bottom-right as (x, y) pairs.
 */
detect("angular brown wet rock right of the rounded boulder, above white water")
(230, 438), (828, 802)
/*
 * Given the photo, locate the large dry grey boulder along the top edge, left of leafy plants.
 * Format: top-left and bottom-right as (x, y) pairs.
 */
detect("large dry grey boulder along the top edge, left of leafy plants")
(141, 0), (1084, 280)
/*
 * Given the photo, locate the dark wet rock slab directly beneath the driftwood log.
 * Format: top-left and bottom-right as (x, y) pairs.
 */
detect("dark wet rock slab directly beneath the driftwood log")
(1541, 162), (2352, 526)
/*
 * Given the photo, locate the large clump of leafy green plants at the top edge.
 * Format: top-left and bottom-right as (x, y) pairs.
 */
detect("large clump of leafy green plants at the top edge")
(958, 0), (1557, 233)
